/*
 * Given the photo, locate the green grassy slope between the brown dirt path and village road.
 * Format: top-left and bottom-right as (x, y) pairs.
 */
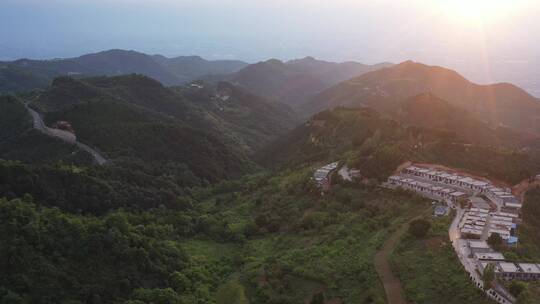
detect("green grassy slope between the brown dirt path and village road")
(392, 213), (491, 304)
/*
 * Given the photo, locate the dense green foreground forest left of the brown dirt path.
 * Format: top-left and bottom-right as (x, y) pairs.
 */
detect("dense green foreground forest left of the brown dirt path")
(0, 167), (426, 303)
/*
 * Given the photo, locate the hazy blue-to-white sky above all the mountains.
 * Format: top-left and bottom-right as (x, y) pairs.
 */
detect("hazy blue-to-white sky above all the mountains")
(0, 0), (540, 91)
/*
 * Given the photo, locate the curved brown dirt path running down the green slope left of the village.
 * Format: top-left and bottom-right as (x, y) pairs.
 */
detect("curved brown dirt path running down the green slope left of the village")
(375, 209), (431, 304)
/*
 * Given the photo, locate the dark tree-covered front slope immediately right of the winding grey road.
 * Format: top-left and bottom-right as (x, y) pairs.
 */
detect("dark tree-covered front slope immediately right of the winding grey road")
(32, 75), (250, 181)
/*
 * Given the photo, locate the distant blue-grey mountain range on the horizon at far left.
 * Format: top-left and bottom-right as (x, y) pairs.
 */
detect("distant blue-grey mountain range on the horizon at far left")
(0, 50), (246, 93)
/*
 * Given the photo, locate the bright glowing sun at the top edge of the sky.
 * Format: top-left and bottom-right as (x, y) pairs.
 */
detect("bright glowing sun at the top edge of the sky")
(435, 0), (516, 23)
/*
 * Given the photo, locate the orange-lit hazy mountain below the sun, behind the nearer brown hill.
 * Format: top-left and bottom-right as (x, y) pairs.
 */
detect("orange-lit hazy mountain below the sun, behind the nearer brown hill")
(303, 61), (540, 135)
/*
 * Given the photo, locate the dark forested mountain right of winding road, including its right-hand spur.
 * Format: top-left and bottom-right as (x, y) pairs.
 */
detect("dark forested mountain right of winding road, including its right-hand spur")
(27, 74), (297, 175)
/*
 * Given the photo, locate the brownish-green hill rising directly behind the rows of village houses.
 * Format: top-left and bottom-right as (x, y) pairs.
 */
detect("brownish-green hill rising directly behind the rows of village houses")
(257, 105), (540, 183)
